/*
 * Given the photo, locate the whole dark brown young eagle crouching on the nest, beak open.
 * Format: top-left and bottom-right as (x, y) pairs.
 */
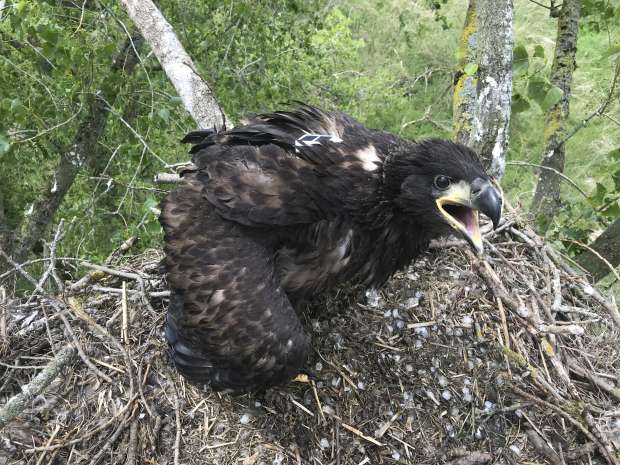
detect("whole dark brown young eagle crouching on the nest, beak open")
(160, 103), (503, 393)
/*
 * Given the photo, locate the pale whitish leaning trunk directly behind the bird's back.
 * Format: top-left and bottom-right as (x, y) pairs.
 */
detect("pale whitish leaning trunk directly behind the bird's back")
(122, 0), (232, 130)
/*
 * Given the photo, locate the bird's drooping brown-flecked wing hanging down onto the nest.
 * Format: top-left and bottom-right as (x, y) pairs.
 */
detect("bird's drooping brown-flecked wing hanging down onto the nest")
(161, 173), (309, 391)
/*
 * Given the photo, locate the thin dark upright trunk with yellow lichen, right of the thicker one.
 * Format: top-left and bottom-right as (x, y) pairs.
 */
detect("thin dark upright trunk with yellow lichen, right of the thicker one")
(530, 0), (581, 222)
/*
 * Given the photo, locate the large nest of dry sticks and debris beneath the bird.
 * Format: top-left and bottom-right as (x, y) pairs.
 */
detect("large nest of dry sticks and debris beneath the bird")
(0, 211), (620, 465)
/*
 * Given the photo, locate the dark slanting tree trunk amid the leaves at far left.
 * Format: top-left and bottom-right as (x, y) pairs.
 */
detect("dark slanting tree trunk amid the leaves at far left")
(13, 38), (142, 263)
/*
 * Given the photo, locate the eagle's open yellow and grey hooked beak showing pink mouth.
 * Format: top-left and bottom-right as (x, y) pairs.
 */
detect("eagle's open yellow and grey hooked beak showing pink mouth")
(435, 178), (502, 254)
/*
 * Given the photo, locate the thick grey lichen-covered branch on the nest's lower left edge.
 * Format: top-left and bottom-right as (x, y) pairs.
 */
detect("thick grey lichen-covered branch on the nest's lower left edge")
(0, 346), (76, 430)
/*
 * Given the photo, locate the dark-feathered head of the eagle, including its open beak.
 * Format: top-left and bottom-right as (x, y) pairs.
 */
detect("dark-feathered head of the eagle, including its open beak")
(384, 139), (503, 253)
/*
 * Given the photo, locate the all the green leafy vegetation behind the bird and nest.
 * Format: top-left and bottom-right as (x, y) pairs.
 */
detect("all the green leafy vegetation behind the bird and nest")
(0, 0), (620, 286)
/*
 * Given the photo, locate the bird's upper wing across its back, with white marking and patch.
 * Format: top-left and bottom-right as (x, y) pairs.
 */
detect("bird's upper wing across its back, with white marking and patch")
(185, 106), (398, 226)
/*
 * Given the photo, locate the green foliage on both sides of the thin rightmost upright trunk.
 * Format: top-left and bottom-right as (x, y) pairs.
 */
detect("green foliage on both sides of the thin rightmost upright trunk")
(504, 0), (620, 253)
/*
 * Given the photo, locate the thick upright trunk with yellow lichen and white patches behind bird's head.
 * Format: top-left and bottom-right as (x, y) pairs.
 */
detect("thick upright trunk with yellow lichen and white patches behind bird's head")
(452, 0), (513, 178)
